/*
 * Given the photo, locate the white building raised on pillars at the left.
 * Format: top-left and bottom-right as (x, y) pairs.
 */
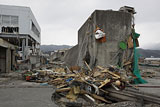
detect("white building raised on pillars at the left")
(0, 5), (41, 60)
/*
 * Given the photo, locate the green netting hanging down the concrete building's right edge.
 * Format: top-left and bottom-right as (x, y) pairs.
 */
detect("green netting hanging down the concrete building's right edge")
(133, 32), (147, 84)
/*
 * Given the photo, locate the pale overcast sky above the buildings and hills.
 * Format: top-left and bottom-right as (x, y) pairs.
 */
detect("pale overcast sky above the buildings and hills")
(0, 0), (160, 48)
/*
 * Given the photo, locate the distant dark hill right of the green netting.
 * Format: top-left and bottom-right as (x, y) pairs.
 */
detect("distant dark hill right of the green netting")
(138, 48), (160, 58)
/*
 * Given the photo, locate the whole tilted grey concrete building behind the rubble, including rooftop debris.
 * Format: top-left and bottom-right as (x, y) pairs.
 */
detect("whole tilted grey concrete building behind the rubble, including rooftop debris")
(65, 7), (135, 67)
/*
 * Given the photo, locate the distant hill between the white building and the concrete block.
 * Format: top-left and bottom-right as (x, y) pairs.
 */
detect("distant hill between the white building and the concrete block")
(40, 45), (72, 53)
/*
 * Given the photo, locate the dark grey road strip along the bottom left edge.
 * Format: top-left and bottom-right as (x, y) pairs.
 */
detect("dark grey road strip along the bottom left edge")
(0, 88), (57, 107)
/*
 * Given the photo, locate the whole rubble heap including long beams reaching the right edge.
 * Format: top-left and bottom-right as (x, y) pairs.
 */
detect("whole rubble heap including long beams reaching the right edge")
(22, 61), (159, 107)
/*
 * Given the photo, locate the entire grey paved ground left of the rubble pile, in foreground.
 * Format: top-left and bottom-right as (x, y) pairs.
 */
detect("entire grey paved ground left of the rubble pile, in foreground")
(0, 73), (57, 107)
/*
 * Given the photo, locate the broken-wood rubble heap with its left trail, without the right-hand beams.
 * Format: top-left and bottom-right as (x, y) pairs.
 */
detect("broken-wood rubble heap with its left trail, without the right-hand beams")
(22, 61), (144, 106)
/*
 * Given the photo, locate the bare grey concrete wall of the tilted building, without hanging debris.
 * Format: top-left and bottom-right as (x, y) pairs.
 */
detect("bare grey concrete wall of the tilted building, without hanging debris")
(63, 10), (132, 67)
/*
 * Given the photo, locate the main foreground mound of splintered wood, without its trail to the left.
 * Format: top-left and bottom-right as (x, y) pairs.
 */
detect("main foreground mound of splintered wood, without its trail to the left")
(50, 64), (139, 106)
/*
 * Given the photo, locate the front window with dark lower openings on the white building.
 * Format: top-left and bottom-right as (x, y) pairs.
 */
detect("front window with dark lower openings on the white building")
(0, 15), (19, 33)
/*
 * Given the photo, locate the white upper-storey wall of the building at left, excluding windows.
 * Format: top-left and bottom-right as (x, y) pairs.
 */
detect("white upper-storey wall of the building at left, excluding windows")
(0, 5), (41, 43)
